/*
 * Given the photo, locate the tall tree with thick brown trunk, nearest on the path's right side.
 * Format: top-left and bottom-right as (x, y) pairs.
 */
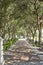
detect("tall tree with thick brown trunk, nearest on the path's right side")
(30, 0), (43, 45)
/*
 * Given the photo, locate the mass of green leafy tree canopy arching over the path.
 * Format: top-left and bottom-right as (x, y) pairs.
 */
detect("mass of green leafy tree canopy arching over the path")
(0, 0), (43, 49)
